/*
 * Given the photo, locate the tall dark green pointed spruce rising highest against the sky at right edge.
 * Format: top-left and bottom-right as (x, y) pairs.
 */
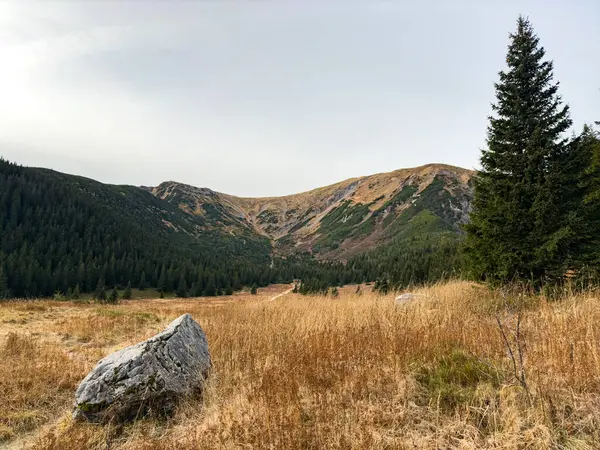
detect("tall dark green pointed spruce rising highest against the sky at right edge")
(465, 17), (573, 285)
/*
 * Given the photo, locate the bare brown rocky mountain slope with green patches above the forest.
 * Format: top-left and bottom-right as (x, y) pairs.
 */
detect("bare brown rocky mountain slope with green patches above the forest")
(146, 164), (473, 259)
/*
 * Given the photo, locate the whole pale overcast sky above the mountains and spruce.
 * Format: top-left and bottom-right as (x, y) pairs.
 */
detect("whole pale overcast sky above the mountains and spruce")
(0, 0), (600, 196)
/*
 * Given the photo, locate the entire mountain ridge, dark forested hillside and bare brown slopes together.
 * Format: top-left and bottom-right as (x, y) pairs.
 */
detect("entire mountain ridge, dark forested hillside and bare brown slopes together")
(0, 158), (472, 298)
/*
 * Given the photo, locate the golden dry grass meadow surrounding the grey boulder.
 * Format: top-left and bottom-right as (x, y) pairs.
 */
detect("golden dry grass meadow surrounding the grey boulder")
(0, 281), (600, 450)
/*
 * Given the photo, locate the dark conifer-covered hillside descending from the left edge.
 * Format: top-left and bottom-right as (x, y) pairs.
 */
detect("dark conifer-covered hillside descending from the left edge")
(0, 160), (271, 297)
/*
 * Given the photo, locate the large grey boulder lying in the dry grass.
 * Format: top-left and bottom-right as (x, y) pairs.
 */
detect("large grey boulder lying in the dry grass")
(73, 314), (211, 423)
